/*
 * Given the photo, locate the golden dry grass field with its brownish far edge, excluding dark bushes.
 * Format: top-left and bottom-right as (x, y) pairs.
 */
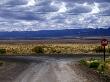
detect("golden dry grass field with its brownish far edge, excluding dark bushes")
(0, 39), (110, 55)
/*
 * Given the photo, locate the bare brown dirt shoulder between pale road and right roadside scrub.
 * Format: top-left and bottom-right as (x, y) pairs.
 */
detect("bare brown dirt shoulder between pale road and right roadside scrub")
(69, 63), (106, 82)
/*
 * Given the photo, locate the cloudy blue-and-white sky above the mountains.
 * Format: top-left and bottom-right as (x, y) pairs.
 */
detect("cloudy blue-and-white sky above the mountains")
(0, 0), (110, 31)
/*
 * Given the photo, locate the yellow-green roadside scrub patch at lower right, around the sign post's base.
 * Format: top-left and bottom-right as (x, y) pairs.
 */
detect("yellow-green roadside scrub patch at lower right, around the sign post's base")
(80, 58), (110, 77)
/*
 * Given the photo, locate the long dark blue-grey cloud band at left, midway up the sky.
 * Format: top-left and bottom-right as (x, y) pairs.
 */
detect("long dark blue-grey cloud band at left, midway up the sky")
(0, 10), (44, 21)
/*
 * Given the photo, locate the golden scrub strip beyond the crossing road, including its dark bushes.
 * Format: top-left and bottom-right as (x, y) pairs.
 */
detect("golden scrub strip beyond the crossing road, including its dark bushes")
(0, 42), (110, 55)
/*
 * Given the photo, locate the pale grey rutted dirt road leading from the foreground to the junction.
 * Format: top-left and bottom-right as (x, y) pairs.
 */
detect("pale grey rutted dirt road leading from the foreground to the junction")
(13, 59), (104, 82)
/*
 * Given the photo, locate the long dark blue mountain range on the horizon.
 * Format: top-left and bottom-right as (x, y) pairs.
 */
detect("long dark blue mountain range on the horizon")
(0, 28), (110, 40)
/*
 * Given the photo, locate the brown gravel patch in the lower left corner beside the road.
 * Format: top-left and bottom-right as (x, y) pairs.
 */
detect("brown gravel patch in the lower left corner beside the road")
(0, 62), (29, 82)
